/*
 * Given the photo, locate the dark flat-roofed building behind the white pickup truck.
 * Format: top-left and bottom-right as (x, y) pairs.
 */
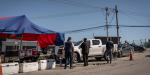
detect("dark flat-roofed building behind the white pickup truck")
(94, 36), (121, 44)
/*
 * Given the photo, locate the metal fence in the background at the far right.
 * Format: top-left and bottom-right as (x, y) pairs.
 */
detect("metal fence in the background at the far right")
(121, 39), (150, 48)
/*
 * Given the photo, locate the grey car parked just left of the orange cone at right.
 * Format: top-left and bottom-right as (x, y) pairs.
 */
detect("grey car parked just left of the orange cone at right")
(118, 44), (134, 58)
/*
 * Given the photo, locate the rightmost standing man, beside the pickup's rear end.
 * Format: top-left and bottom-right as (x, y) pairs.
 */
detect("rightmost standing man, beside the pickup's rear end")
(106, 37), (114, 63)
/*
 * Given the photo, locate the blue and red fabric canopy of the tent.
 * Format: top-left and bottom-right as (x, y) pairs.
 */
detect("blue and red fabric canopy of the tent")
(0, 15), (65, 48)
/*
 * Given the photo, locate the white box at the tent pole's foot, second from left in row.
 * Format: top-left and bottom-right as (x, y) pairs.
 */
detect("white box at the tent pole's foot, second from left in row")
(19, 62), (38, 73)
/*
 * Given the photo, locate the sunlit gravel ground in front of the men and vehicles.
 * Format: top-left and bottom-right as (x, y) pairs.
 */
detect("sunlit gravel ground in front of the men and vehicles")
(15, 48), (150, 75)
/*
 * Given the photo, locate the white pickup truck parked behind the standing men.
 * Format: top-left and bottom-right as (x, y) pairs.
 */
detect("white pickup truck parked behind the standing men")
(73, 39), (117, 63)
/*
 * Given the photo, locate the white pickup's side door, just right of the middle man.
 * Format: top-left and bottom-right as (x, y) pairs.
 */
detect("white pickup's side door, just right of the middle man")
(90, 40), (102, 55)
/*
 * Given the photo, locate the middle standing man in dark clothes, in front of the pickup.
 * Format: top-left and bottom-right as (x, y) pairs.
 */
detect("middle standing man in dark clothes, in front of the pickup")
(81, 38), (90, 66)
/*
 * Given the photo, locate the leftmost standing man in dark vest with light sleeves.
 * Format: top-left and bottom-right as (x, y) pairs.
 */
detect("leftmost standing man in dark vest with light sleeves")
(64, 37), (74, 69)
